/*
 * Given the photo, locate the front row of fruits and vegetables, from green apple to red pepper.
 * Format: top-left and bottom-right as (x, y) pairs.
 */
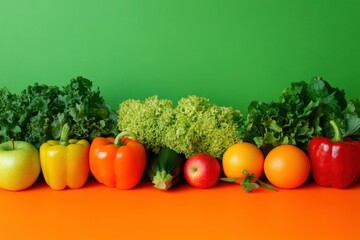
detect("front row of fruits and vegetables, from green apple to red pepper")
(0, 121), (360, 192)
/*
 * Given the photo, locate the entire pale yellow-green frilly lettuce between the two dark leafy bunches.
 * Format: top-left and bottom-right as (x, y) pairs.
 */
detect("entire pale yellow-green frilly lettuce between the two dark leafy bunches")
(118, 96), (242, 158)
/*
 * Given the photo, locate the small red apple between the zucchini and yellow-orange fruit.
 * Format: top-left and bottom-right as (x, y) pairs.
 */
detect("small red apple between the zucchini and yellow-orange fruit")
(184, 153), (220, 188)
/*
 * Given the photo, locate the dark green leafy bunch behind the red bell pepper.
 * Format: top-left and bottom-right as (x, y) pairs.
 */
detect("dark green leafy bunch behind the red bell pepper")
(240, 77), (360, 154)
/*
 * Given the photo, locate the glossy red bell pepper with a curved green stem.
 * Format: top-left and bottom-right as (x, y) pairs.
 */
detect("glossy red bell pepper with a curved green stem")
(309, 121), (360, 188)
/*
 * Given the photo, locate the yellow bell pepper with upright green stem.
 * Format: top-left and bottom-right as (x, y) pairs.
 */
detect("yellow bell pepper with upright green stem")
(40, 124), (90, 190)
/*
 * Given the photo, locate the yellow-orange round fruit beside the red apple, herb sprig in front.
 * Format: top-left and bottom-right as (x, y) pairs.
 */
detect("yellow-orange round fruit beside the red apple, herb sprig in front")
(222, 142), (264, 179)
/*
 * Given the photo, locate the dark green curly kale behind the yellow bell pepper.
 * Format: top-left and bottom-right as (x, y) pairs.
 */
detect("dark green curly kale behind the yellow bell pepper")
(0, 77), (117, 147)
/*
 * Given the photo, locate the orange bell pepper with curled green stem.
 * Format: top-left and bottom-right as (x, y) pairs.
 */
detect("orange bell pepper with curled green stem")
(89, 132), (146, 190)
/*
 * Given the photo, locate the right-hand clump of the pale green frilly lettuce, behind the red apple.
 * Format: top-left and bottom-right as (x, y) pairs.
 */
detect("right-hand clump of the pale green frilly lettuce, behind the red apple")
(165, 96), (242, 158)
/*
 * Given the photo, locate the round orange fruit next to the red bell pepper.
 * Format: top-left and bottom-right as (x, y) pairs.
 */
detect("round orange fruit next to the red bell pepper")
(264, 144), (310, 188)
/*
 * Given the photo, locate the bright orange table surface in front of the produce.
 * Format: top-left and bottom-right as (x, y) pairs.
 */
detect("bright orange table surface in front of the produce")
(0, 179), (360, 240)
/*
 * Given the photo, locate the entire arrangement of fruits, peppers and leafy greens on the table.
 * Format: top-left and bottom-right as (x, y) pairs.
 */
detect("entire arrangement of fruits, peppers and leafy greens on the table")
(0, 77), (360, 192)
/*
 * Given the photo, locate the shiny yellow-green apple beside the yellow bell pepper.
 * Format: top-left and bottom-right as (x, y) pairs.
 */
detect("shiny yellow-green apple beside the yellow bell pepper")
(0, 141), (40, 191)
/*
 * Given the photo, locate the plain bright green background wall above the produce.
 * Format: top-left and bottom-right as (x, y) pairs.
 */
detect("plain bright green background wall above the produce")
(0, 0), (360, 111)
